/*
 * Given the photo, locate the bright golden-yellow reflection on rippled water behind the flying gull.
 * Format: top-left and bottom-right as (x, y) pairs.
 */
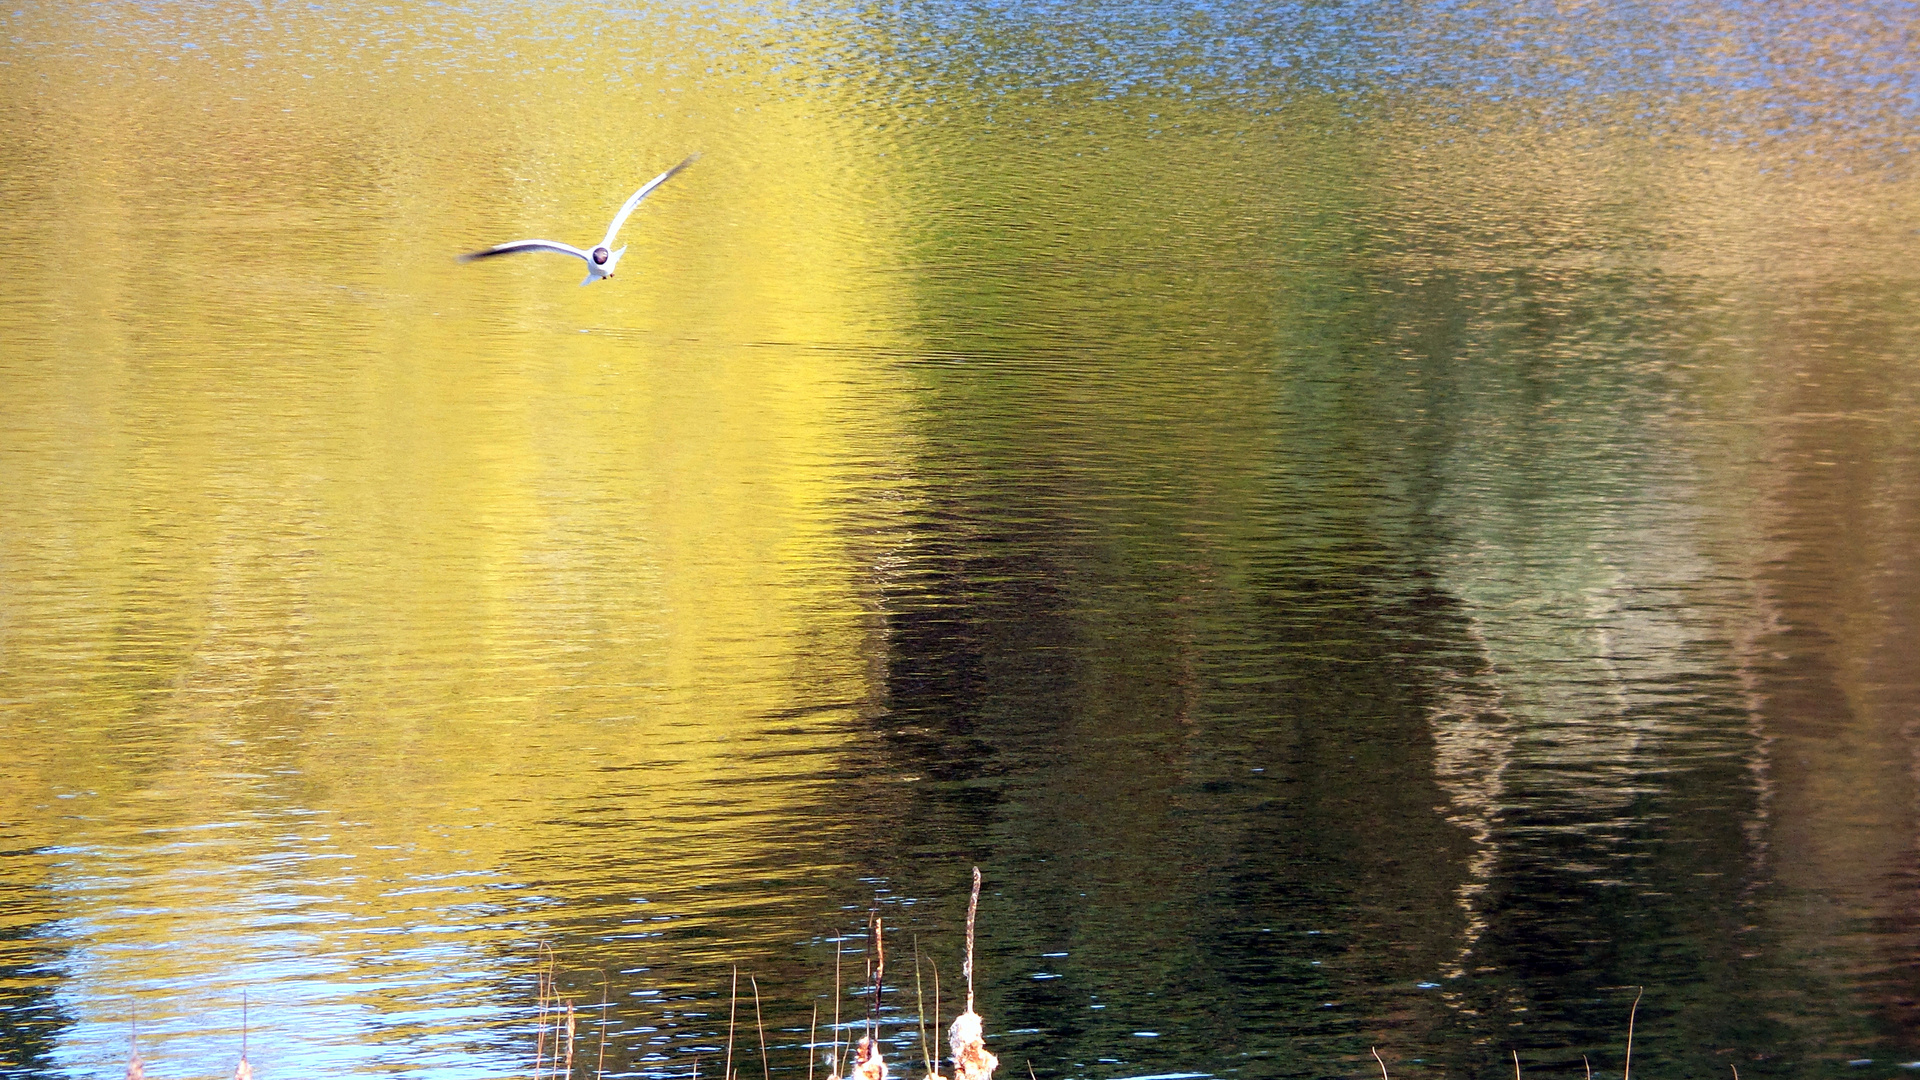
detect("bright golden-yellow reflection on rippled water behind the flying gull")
(0, 6), (925, 1060)
